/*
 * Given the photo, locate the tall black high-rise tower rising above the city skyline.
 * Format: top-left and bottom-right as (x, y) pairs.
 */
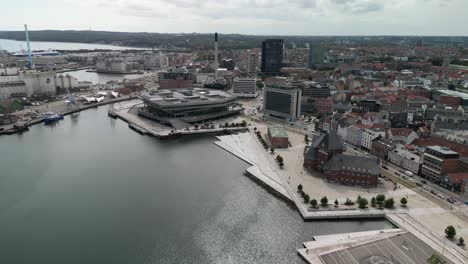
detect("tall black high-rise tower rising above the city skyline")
(262, 39), (284, 75)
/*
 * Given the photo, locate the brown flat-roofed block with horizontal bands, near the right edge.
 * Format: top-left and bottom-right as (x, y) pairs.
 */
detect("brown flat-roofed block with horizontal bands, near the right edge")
(421, 146), (459, 183)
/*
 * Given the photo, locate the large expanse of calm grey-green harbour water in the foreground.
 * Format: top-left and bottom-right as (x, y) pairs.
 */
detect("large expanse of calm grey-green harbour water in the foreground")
(0, 107), (391, 264)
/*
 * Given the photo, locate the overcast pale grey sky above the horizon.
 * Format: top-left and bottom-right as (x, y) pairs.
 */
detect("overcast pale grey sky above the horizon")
(0, 0), (468, 36)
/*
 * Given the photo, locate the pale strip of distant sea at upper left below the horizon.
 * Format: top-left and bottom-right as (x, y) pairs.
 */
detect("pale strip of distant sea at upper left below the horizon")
(0, 39), (144, 52)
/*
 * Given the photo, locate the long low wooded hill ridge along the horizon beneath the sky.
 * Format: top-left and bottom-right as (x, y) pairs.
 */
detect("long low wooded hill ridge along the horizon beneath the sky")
(0, 30), (468, 49)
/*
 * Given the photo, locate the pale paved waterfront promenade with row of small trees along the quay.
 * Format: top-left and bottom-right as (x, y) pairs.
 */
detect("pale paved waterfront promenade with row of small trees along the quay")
(215, 129), (468, 264)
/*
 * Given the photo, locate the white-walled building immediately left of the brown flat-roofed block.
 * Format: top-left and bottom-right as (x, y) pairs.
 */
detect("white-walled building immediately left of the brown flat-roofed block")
(388, 145), (422, 175)
